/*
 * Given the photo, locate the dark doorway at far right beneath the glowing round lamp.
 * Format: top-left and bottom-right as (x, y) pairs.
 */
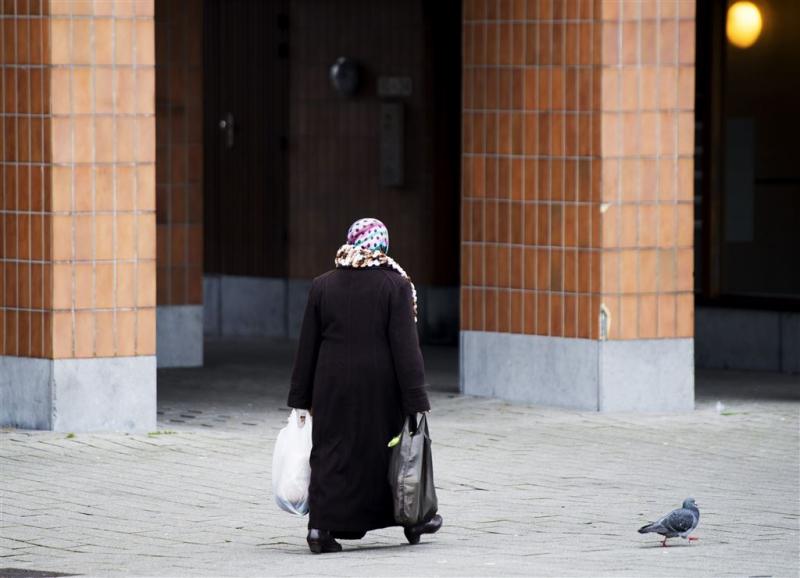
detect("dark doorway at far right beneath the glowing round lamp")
(695, 0), (800, 311)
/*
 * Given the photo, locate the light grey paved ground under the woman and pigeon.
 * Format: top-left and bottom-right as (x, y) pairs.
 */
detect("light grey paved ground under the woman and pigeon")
(0, 343), (800, 576)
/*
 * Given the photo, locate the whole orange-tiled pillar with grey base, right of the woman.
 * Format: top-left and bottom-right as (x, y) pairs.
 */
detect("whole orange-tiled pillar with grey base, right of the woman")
(462, 0), (694, 410)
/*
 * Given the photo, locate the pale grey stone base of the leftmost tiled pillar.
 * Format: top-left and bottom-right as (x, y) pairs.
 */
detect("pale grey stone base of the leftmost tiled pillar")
(0, 356), (156, 432)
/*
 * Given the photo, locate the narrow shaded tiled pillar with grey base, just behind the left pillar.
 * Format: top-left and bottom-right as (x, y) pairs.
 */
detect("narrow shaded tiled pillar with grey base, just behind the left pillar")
(155, 0), (203, 367)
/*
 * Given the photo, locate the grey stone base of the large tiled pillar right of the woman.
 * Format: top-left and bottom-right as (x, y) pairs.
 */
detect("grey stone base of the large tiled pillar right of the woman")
(460, 331), (694, 412)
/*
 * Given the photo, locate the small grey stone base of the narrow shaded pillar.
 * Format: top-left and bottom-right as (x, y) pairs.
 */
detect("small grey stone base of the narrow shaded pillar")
(156, 305), (203, 367)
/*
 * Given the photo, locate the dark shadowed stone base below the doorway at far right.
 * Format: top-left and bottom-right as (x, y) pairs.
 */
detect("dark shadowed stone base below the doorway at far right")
(695, 307), (800, 373)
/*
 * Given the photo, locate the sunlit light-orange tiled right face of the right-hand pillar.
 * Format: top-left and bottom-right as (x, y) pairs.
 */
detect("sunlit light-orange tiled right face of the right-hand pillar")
(599, 0), (695, 339)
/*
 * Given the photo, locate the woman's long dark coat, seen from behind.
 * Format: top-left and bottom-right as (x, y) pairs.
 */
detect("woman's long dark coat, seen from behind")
(289, 267), (430, 537)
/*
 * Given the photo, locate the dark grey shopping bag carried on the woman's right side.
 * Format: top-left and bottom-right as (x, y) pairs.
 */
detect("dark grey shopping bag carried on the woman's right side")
(389, 414), (439, 526)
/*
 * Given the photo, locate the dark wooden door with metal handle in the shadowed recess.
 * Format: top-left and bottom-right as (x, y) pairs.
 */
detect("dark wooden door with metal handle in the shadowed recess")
(204, 0), (289, 277)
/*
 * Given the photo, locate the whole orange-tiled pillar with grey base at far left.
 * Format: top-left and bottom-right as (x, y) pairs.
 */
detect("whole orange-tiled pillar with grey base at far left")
(0, 0), (156, 431)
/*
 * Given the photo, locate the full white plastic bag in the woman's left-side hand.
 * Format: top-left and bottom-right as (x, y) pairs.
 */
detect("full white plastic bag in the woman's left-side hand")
(272, 409), (312, 516)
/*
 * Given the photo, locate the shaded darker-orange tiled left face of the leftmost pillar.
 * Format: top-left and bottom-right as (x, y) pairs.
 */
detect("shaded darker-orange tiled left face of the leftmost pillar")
(0, 2), (52, 357)
